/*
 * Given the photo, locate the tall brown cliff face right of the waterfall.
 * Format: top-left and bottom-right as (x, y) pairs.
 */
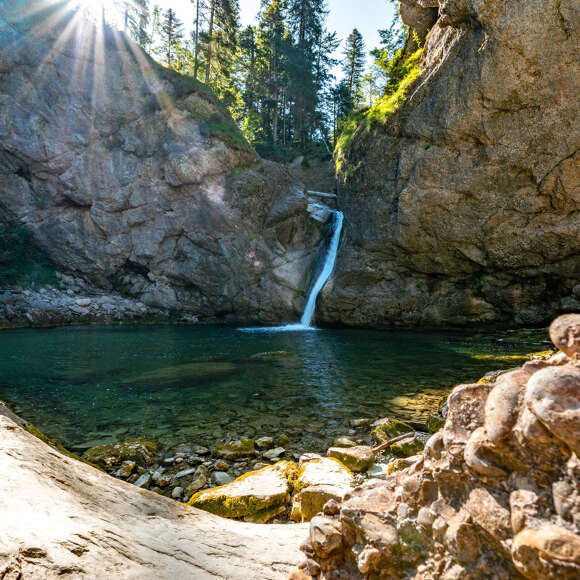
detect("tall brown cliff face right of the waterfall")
(320, 0), (580, 326)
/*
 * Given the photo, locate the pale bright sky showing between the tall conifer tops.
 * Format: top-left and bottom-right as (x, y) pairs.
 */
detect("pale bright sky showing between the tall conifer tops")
(168, 0), (395, 77)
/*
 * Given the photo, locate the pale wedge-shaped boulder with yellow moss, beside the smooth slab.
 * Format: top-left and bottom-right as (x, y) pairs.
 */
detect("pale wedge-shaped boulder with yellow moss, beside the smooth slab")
(187, 461), (298, 523)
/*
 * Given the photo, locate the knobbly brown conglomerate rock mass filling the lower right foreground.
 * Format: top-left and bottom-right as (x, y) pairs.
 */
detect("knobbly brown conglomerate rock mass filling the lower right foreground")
(291, 315), (580, 580)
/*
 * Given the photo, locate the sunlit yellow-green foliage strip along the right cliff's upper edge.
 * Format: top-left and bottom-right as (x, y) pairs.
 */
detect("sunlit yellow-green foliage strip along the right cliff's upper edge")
(335, 49), (422, 171)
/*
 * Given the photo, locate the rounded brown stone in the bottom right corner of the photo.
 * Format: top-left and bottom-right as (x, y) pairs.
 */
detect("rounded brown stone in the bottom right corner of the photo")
(512, 524), (580, 580)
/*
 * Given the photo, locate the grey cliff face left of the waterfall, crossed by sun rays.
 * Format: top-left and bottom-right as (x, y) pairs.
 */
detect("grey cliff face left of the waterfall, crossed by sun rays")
(0, 0), (324, 322)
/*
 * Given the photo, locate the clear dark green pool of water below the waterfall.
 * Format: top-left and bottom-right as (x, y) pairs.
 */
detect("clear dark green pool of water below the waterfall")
(0, 326), (546, 450)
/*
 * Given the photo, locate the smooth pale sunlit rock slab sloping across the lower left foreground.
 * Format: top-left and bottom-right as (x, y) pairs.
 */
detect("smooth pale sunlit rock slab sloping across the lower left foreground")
(0, 416), (307, 580)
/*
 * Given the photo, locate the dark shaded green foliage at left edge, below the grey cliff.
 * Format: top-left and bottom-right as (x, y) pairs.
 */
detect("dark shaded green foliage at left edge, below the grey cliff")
(0, 225), (56, 287)
